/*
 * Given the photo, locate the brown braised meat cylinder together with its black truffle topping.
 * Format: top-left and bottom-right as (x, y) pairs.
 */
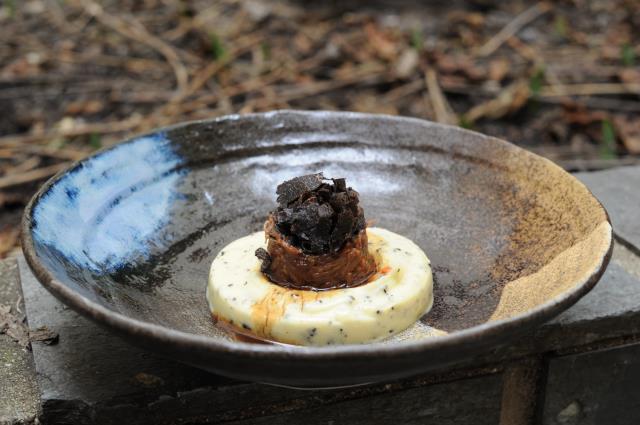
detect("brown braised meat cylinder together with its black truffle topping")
(255, 174), (377, 290)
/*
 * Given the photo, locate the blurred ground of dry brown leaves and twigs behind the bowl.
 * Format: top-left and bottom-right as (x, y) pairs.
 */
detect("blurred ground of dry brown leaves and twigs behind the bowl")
(0, 0), (640, 257)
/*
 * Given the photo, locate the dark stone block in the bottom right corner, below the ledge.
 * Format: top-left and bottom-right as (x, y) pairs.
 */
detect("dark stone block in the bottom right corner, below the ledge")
(543, 344), (640, 425)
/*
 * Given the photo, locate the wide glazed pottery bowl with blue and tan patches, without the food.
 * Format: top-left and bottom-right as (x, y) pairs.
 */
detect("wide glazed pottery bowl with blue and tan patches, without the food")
(22, 111), (612, 387)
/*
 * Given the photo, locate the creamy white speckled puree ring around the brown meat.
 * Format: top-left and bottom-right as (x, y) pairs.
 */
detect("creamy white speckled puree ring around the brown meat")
(207, 227), (433, 345)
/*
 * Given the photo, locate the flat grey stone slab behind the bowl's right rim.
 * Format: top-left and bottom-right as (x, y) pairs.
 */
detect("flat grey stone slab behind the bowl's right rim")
(575, 166), (640, 252)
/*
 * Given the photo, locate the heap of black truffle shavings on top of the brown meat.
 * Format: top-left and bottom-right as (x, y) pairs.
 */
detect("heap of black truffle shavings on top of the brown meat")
(273, 173), (365, 255)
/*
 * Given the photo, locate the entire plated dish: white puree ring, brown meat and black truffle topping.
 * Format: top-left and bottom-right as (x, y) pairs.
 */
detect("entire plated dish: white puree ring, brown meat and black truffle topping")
(207, 174), (433, 345)
